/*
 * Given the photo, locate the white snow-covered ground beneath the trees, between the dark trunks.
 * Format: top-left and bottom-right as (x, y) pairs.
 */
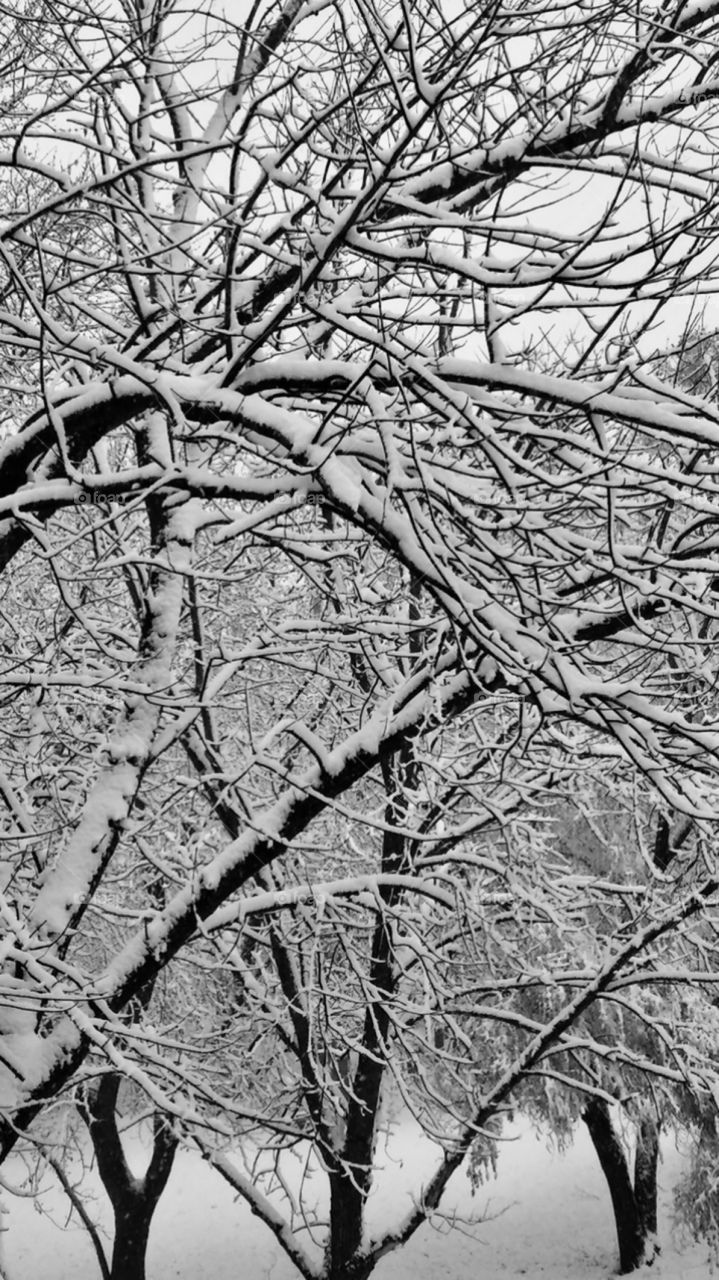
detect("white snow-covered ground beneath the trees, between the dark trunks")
(3, 1123), (710, 1280)
